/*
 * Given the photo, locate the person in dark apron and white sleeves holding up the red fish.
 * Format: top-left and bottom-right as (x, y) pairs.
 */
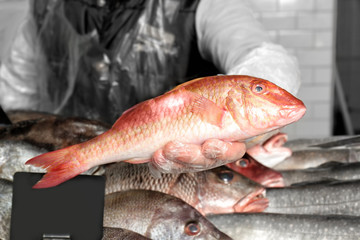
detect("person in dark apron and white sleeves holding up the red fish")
(0, 0), (300, 172)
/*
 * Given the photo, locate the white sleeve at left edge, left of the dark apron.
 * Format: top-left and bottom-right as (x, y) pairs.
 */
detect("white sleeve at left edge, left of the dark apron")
(0, 17), (42, 110)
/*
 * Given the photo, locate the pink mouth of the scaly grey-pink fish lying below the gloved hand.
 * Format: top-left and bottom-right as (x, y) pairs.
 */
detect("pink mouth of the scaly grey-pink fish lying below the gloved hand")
(233, 188), (269, 212)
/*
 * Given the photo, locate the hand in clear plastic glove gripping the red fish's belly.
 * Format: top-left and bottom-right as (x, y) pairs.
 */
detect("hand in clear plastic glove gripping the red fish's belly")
(149, 139), (246, 176)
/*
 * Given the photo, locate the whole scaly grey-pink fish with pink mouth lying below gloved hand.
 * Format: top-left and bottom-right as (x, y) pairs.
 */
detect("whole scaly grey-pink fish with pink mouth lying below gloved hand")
(105, 162), (267, 215)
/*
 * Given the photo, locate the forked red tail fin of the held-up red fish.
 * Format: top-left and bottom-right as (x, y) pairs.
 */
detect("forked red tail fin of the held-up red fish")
(25, 146), (89, 188)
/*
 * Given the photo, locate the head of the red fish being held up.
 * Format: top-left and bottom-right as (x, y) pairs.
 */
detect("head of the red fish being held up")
(226, 77), (306, 136)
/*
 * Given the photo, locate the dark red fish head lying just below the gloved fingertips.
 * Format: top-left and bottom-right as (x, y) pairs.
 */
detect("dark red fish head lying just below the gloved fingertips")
(226, 153), (284, 188)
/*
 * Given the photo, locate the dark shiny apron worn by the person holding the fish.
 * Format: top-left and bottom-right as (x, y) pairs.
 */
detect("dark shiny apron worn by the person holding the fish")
(32, 0), (218, 123)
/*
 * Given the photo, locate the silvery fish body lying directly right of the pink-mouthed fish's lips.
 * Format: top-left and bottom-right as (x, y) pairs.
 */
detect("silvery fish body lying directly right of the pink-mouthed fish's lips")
(264, 180), (360, 216)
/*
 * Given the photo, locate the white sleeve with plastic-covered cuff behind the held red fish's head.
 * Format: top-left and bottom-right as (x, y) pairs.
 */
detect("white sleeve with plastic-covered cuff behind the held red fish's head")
(195, 0), (300, 95)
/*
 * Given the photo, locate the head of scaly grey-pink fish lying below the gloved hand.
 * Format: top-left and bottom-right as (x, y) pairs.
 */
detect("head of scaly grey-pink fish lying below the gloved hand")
(197, 166), (268, 215)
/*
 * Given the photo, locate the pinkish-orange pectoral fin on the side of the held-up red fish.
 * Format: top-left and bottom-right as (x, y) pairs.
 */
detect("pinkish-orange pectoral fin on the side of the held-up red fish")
(184, 90), (226, 127)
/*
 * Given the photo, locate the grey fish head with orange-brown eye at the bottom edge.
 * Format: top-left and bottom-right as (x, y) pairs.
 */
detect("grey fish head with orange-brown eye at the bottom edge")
(147, 197), (231, 240)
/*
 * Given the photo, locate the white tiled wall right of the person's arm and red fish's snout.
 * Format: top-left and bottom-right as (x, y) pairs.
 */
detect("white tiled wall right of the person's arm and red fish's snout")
(249, 0), (336, 139)
